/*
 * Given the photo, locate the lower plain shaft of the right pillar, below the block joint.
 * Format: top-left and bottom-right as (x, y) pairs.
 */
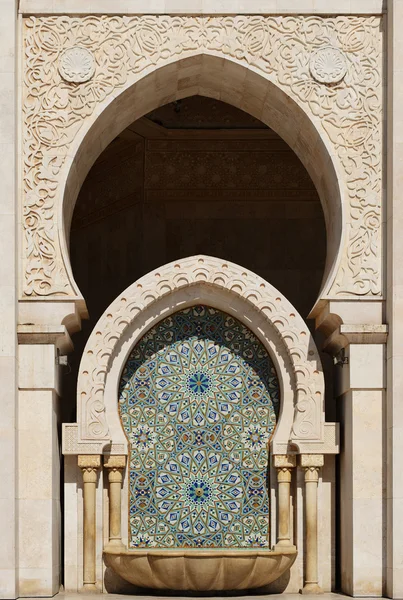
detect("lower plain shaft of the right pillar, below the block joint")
(339, 389), (385, 595)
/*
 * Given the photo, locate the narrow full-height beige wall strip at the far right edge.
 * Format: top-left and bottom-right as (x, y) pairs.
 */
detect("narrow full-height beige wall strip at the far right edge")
(385, 0), (403, 597)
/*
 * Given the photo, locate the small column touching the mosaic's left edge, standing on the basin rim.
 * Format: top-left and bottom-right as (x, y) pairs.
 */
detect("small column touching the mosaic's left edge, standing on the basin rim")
(104, 456), (126, 547)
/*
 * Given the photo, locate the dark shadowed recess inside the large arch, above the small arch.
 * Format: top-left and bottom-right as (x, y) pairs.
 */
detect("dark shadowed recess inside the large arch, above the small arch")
(64, 96), (326, 420)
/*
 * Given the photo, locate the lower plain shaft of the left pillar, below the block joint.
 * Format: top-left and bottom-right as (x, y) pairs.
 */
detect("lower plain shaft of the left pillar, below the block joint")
(18, 390), (61, 596)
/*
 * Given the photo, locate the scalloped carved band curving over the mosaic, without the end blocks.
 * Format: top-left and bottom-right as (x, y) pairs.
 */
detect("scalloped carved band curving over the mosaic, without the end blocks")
(77, 256), (324, 443)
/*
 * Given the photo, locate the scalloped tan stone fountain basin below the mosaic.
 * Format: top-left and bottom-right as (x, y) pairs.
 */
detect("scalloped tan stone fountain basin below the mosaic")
(104, 547), (297, 592)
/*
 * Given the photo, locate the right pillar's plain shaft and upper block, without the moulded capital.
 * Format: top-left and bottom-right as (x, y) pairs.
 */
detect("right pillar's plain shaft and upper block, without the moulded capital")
(336, 338), (385, 596)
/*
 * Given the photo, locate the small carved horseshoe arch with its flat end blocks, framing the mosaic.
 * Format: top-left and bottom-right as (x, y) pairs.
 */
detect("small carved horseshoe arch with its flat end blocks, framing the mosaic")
(63, 255), (338, 454)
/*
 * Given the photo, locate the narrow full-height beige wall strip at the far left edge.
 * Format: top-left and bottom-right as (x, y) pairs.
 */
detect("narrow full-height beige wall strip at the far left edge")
(0, 0), (18, 598)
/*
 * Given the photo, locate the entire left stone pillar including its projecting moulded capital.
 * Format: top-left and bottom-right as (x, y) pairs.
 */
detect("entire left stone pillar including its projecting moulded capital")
(17, 304), (79, 597)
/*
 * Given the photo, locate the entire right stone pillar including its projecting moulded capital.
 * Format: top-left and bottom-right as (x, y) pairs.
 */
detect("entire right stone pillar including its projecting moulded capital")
(316, 308), (386, 596)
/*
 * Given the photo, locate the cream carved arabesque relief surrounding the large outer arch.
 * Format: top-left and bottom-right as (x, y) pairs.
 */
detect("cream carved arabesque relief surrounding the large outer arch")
(23, 16), (382, 298)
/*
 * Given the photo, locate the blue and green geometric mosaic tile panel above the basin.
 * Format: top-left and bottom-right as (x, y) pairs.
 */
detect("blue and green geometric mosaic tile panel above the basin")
(119, 306), (279, 548)
